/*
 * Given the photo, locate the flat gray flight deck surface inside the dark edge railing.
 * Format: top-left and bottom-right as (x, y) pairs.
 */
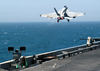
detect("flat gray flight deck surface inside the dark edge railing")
(19, 49), (100, 71)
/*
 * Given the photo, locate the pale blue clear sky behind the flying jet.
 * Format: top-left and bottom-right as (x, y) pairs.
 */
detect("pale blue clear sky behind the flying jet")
(0, 0), (100, 22)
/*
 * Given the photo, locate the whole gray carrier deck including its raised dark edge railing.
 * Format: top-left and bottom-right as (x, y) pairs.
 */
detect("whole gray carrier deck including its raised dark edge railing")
(0, 42), (100, 71)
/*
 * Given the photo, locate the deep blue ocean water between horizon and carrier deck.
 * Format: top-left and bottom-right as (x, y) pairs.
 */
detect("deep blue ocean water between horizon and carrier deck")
(0, 21), (100, 63)
